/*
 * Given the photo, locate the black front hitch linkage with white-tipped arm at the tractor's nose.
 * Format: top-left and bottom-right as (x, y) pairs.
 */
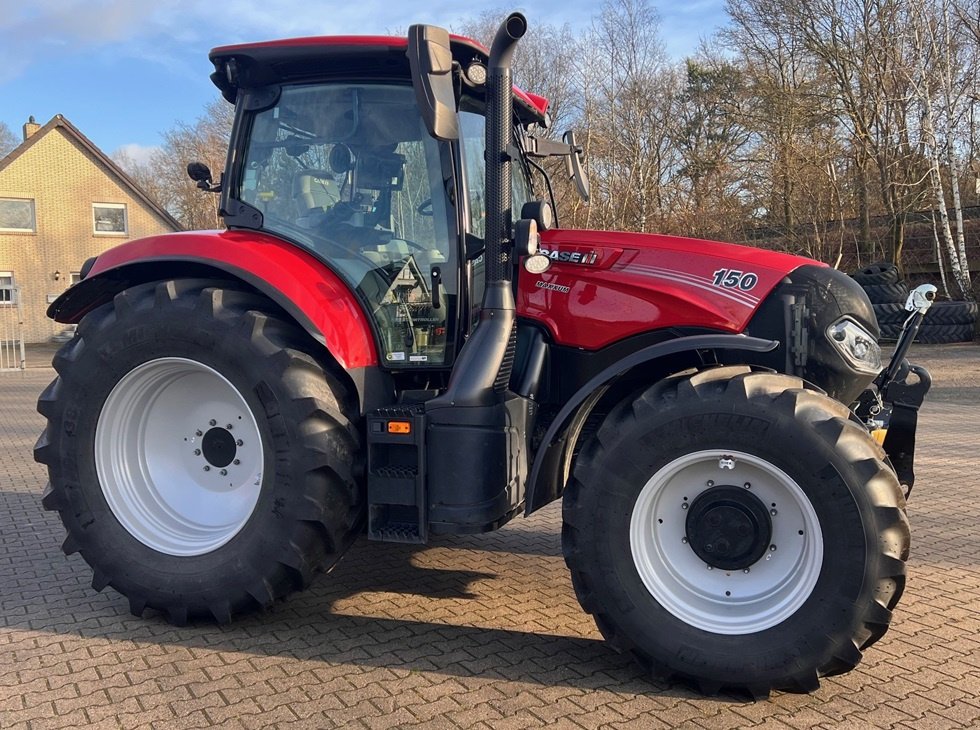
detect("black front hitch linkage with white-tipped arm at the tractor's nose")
(856, 284), (936, 498)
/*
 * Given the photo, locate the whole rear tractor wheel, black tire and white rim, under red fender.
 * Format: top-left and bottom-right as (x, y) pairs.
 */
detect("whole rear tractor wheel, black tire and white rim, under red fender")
(35, 280), (364, 624)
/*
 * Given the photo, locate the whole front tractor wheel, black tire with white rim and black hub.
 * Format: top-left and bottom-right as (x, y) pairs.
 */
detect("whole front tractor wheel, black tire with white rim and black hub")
(562, 367), (909, 698)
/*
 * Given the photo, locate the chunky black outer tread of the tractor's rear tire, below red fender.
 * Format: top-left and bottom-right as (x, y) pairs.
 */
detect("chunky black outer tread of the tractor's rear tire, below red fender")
(34, 279), (363, 625)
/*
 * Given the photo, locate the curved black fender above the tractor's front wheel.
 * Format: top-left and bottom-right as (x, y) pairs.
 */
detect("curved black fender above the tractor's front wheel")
(524, 334), (779, 516)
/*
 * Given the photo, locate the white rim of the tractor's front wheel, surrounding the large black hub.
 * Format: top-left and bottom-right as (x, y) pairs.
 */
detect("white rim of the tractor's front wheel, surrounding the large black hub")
(630, 450), (823, 635)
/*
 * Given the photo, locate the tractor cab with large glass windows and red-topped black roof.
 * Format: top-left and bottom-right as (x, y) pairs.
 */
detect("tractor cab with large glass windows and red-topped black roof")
(211, 26), (572, 373)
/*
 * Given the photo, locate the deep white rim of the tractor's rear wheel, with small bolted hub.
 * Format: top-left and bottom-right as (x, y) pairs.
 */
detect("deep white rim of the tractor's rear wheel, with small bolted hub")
(95, 357), (264, 556)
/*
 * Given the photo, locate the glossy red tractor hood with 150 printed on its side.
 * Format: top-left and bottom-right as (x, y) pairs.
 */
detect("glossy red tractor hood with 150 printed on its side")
(517, 230), (825, 350)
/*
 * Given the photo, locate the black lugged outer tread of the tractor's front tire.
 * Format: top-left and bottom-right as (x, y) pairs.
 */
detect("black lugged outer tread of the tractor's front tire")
(562, 367), (909, 699)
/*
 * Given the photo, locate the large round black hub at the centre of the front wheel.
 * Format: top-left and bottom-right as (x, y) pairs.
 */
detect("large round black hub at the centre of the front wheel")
(685, 486), (772, 570)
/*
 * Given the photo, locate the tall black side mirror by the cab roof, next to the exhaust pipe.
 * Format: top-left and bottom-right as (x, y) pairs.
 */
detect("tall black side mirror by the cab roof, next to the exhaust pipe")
(407, 25), (459, 141)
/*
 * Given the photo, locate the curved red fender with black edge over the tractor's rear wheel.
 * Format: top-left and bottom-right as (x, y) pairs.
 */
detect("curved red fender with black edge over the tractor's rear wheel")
(48, 231), (387, 409)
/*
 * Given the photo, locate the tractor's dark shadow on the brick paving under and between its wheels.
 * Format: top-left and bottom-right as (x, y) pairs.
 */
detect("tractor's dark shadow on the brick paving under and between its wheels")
(0, 491), (716, 702)
